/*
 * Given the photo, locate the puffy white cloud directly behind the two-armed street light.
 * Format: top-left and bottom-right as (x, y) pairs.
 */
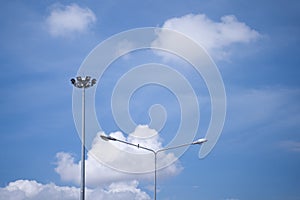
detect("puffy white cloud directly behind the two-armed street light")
(55, 125), (182, 187)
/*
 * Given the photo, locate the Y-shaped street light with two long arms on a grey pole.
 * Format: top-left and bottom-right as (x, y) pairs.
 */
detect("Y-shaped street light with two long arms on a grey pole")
(100, 135), (207, 200)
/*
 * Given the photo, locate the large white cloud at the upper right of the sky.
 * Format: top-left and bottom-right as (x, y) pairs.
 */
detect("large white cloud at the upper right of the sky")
(155, 14), (260, 59)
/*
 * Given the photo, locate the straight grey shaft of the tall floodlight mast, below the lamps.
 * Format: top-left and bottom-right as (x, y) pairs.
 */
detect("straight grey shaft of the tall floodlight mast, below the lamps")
(80, 87), (85, 200)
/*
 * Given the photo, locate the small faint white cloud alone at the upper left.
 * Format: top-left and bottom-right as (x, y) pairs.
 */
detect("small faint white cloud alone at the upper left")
(46, 4), (96, 36)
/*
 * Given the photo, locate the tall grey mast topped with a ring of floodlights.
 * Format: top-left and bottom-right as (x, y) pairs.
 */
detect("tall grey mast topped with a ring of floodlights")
(71, 76), (96, 200)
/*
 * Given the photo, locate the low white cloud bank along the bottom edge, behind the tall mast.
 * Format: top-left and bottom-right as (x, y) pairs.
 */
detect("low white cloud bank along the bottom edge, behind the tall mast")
(0, 180), (150, 200)
